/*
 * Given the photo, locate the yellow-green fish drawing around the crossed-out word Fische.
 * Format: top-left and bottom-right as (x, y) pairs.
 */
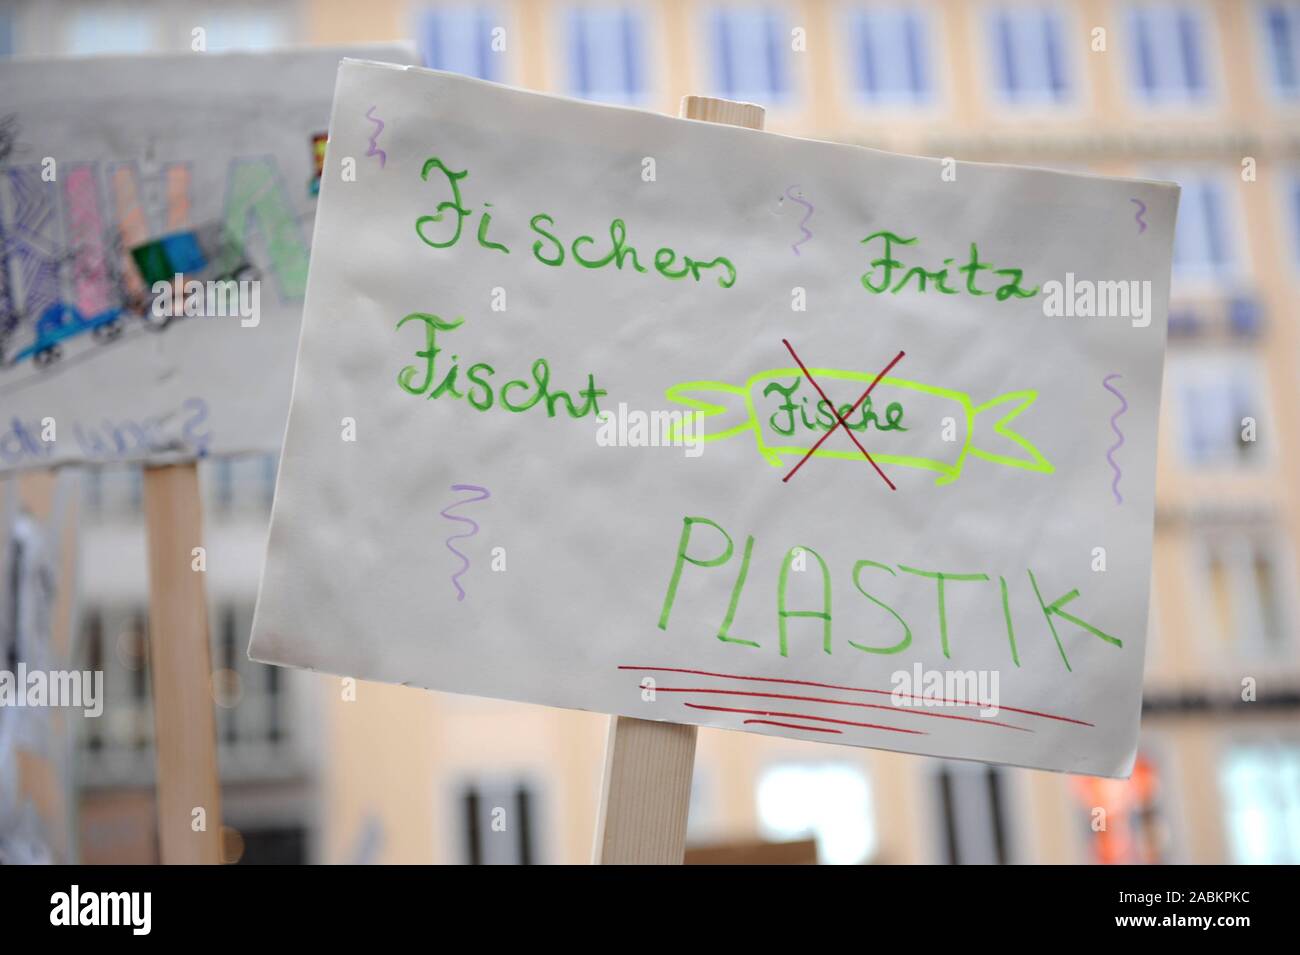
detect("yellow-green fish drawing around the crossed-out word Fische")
(664, 368), (1056, 485)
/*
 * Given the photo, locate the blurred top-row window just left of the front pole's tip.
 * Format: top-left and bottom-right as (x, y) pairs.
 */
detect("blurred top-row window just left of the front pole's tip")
(568, 8), (646, 103)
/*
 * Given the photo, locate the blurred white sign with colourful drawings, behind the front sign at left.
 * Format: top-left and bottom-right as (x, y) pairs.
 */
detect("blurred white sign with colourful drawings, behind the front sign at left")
(0, 45), (411, 472)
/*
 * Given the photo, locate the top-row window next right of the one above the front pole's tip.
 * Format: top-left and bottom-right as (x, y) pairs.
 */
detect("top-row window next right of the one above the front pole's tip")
(849, 8), (933, 105)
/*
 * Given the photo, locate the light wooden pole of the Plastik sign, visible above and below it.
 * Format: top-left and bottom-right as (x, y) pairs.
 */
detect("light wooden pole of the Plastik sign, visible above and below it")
(594, 96), (763, 865)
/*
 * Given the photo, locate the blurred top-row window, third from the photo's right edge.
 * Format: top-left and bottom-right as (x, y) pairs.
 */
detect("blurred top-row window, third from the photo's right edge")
(992, 6), (1070, 105)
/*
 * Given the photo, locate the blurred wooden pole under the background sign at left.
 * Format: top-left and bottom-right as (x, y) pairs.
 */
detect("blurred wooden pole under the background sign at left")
(144, 463), (221, 865)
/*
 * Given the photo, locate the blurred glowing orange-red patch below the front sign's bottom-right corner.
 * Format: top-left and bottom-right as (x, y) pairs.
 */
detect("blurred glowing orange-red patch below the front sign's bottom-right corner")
(1070, 752), (1170, 865)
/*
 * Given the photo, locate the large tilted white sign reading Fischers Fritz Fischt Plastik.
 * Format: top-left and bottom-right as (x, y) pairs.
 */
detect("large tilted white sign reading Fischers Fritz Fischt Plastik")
(251, 61), (1178, 774)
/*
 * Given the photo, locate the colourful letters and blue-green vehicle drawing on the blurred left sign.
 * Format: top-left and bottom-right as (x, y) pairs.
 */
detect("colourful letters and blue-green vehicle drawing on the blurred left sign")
(0, 159), (307, 391)
